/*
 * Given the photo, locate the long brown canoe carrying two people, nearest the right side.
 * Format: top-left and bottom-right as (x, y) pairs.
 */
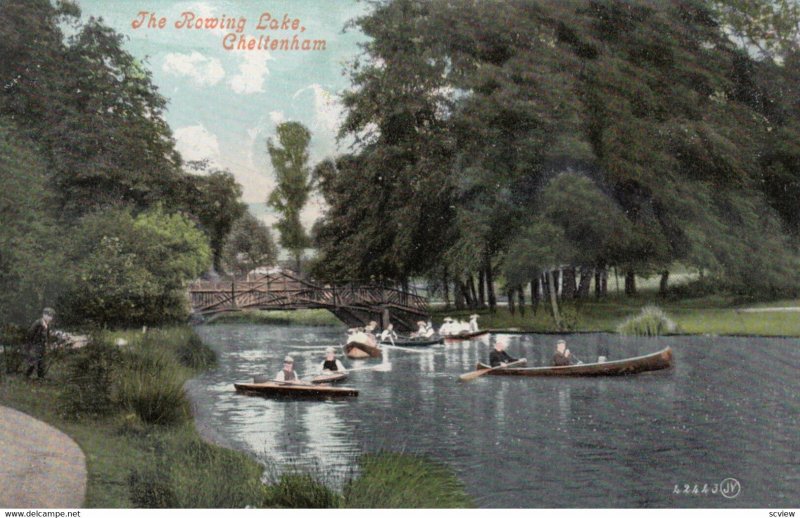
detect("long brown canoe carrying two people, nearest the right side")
(475, 347), (672, 376)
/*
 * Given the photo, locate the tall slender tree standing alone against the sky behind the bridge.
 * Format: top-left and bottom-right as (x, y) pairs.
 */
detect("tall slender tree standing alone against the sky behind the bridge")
(267, 122), (311, 272)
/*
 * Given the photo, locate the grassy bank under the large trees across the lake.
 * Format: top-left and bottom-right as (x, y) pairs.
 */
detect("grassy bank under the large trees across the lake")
(434, 294), (800, 336)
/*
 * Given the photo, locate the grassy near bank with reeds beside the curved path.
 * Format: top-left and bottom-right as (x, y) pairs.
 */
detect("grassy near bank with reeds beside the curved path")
(0, 327), (472, 508)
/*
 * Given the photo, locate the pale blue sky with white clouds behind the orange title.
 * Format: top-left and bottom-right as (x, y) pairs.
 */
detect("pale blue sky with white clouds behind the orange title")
(78, 0), (367, 228)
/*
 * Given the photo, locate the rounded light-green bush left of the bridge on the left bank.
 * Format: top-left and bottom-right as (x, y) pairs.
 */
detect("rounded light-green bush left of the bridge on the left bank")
(62, 208), (210, 325)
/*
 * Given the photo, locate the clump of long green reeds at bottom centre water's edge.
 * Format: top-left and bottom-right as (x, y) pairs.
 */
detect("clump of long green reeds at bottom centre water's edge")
(344, 452), (473, 509)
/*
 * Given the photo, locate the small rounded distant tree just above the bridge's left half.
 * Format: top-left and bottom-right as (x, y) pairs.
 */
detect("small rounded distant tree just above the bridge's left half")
(223, 212), (278, 276)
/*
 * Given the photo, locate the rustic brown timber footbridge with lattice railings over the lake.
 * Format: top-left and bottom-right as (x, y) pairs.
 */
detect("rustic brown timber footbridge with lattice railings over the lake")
(189, 270), (429, 331)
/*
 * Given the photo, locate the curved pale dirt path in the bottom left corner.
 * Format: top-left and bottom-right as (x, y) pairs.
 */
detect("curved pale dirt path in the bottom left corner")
(0, 406), (86, 509)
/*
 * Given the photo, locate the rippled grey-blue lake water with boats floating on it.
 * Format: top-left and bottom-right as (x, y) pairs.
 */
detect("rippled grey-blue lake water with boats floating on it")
(188, 325), (800, 507)
